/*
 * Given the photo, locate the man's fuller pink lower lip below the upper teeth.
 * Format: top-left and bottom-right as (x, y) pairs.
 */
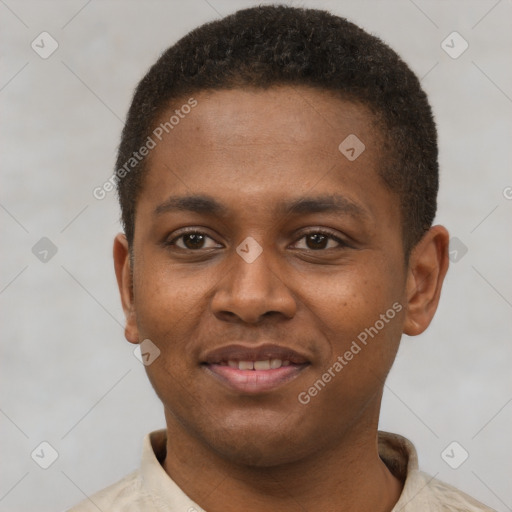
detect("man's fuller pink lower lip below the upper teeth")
(204, 364), (308, 394)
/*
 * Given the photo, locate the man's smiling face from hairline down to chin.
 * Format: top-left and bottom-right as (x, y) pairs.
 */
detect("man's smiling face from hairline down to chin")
(115, 86), (446, 465)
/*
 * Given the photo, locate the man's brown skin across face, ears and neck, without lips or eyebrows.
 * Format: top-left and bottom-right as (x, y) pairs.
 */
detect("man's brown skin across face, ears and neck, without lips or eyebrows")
(114, 86), (449, 512)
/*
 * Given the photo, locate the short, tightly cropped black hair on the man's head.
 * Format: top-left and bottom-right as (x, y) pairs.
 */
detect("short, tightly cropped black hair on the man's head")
(116, 5), (439, 255)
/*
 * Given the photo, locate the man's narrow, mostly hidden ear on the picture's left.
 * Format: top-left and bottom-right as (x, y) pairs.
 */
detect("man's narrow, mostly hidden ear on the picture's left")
(113, 233), (139, 343)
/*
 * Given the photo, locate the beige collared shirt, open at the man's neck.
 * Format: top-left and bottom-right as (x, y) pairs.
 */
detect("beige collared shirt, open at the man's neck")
(68, 430), (494, 512)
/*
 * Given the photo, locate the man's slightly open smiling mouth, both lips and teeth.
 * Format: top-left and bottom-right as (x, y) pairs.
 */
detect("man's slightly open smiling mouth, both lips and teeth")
(201, 345), (311, 394)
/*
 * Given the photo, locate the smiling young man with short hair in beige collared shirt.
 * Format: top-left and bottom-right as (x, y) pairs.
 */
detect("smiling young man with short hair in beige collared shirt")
(73, 6), (491, 512)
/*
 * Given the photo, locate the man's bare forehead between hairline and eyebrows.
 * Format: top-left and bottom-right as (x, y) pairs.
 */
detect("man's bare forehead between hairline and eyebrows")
(141, 86), (396, 226)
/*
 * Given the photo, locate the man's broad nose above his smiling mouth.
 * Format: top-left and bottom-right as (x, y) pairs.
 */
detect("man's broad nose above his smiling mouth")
(211, 250), (297, 324)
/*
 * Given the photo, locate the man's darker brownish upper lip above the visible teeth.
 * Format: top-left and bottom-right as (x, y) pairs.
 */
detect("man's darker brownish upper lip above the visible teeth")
(201, 343), (309, 364)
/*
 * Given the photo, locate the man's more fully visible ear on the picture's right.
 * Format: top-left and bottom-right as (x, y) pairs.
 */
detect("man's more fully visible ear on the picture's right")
(403, 226), (450, 336)
